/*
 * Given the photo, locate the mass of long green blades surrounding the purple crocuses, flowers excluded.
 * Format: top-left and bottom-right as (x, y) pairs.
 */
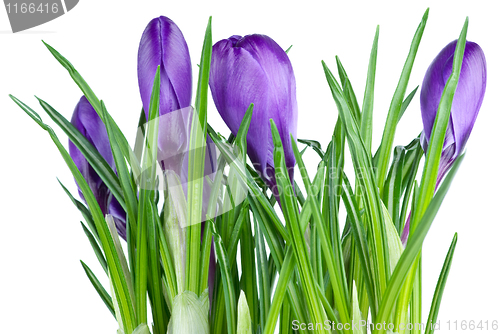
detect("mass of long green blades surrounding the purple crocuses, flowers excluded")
(12, 7), (468, 334)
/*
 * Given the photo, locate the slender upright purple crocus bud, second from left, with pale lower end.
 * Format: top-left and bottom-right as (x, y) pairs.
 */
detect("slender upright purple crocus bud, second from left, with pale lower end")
(137, 16), (192, 172)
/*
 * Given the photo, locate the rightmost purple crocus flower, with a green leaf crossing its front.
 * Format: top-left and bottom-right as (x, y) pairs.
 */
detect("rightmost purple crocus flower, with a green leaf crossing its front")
(402, 40), (486, 243)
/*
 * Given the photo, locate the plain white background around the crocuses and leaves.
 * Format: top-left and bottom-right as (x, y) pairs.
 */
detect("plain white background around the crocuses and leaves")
(0, 0), (500, 333)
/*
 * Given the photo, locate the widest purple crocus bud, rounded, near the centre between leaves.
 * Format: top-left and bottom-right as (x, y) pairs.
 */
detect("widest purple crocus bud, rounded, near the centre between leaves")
(209, 35), (297, 196)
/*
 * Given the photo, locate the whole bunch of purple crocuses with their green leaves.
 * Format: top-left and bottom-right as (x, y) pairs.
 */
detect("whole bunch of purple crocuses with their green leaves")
(12, 11), (486, 334)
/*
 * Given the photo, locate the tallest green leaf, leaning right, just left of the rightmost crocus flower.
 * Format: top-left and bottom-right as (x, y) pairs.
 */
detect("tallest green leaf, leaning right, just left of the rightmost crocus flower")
(377, 9), (429, 194)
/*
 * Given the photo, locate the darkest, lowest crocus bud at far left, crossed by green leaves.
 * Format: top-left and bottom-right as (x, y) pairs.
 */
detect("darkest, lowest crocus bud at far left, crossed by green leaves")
(69, 96), (127, 239)
